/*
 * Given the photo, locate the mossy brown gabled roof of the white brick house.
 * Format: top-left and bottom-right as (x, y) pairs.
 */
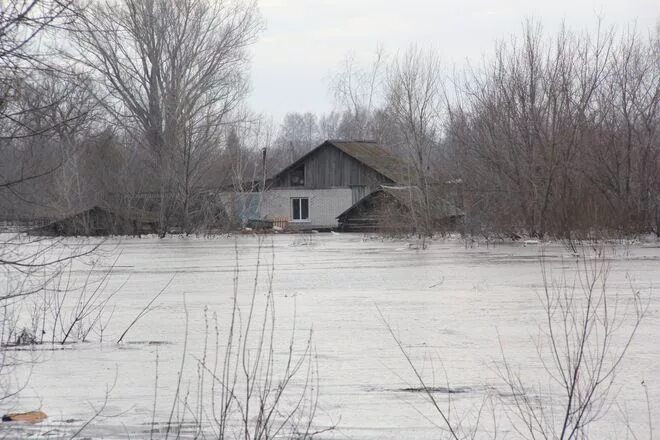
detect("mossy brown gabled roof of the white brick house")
(275, 140), (409, 183)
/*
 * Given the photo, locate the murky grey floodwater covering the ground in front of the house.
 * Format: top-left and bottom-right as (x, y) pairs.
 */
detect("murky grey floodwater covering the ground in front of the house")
(3, 234), (660, 440)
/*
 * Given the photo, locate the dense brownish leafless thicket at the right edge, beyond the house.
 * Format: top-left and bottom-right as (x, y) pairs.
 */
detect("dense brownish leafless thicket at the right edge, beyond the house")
(448, 21), (658, 241)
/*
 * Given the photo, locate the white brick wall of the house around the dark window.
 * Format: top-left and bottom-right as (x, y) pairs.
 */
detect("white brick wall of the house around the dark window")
(261, 188), (353, 228)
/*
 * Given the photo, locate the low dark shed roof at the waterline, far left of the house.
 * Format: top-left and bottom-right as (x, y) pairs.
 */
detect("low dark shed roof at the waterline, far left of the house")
(29, 205), (158, 236)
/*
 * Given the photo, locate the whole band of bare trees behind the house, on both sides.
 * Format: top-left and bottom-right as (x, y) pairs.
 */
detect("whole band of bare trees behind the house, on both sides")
(0, 0), (660, 238)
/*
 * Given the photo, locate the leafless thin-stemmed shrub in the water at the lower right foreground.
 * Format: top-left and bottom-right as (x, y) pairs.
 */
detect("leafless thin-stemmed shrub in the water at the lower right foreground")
(386, 249), (652, 440)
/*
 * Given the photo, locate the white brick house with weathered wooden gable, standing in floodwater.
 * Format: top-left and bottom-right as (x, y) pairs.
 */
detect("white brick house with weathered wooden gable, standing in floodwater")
(260, 140), (409, 230)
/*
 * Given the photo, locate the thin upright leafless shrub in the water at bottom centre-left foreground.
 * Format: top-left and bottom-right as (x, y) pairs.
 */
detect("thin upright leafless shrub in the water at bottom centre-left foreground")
(147, 239), (334, 440)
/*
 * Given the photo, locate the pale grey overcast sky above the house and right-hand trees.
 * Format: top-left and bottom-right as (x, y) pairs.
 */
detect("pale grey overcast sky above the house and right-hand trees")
(249, 0), (660, 122)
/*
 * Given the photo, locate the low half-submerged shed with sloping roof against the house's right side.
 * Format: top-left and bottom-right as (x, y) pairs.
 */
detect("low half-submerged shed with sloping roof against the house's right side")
(337, 185), (463, 234)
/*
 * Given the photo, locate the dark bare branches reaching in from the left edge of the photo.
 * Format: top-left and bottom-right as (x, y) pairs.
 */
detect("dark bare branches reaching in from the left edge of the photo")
(0, 0), (103, 312)
